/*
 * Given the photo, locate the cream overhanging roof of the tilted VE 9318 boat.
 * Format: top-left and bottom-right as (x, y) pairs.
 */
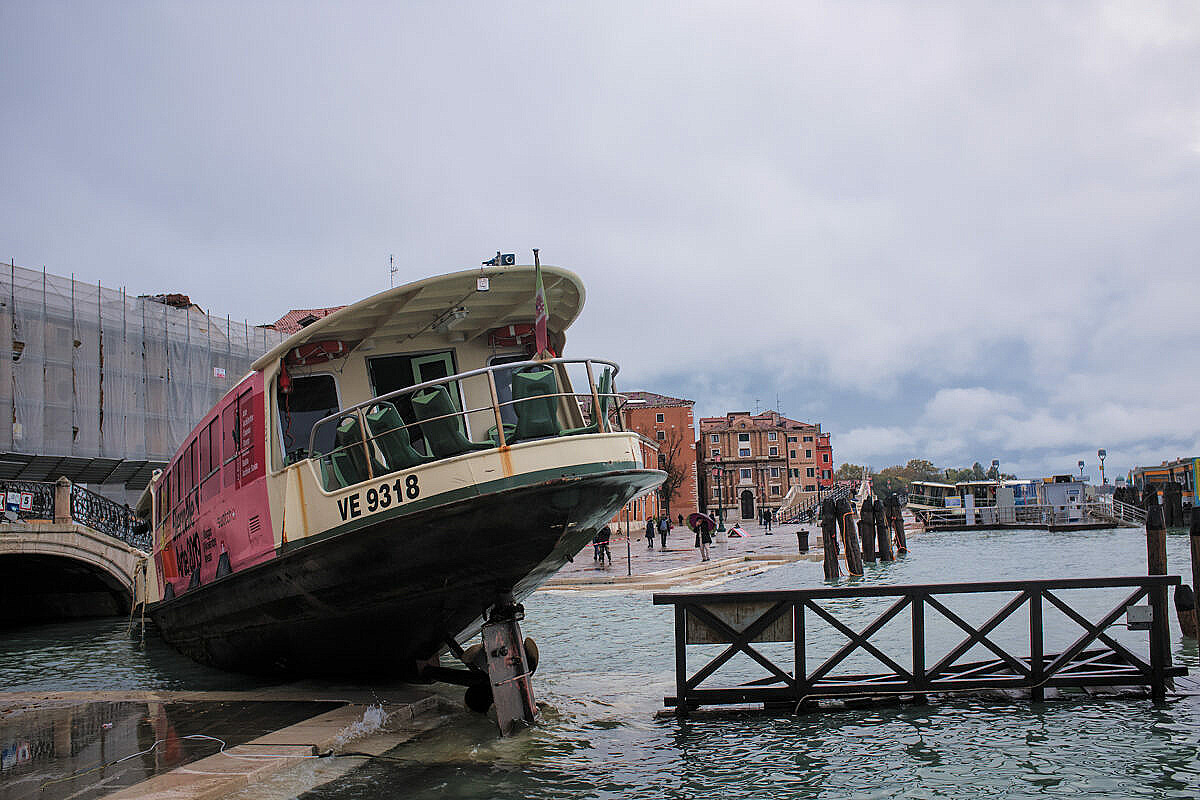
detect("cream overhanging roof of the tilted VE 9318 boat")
(253, 264), (586, 369)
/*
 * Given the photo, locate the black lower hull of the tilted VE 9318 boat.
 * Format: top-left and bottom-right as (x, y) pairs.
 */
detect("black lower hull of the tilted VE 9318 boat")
(150, 470), (661, 676)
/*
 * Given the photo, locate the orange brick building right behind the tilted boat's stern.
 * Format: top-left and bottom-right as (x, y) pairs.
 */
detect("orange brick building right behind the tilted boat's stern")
(622, 392), (700, 522)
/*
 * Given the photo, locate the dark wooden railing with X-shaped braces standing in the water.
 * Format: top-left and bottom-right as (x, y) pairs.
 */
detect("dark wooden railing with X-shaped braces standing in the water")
(654, 576), (1187, 715)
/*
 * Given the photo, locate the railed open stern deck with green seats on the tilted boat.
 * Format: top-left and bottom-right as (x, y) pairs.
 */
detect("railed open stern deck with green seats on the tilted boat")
(306, 359), (625, 491)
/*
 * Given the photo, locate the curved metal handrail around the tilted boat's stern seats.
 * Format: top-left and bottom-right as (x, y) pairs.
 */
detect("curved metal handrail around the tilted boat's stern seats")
(308, 357), (625, 477)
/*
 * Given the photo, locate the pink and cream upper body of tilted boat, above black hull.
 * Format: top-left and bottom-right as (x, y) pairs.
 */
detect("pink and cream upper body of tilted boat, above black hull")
(142, 266), (642, 597)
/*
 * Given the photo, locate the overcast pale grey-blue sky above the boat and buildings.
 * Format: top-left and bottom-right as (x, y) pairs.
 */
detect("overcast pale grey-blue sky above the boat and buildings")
(0, 0), (1200, 477)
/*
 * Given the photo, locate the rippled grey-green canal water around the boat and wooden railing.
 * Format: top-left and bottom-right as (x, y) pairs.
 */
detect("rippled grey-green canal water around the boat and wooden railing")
(0, 529), (1200, 800)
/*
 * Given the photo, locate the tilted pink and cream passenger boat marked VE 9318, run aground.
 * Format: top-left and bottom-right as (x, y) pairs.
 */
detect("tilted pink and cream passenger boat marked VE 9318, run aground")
(139, 265), (664, 675)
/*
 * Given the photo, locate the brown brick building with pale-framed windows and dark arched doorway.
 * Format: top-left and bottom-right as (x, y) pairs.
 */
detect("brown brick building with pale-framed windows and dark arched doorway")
(696, 411), (833, 519)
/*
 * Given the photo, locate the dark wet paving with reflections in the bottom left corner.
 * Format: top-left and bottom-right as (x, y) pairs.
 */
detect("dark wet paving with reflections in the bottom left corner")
(0, 700), (341, 800)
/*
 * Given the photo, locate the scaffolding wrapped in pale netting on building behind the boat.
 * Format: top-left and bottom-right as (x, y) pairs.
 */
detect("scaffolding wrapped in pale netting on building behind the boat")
(0, 264), (287, 494)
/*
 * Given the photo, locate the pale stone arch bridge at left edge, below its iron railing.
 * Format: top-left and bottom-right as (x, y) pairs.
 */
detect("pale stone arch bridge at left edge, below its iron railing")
(0, 521), (148, 626)
